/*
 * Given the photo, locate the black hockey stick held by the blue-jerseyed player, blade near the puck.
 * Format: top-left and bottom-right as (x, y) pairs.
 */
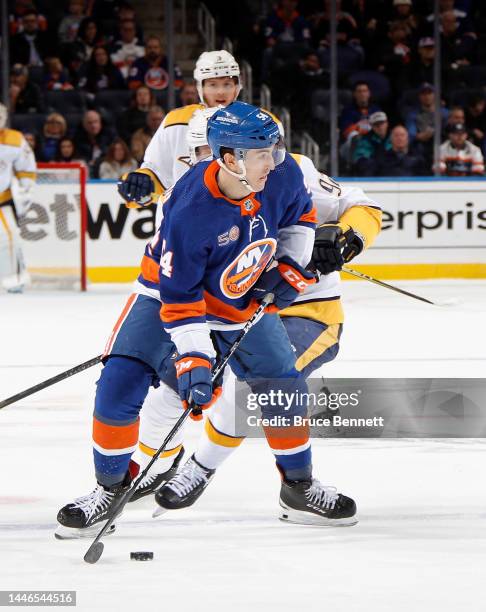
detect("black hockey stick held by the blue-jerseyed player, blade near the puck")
(83, 294), (273, 563)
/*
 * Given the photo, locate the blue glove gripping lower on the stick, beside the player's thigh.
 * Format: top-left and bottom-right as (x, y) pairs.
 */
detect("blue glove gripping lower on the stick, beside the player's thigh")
(175, 353), (213, 420)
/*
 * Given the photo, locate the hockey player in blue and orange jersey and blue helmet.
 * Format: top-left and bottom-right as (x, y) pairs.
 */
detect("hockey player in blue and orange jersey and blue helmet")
(58, 102), (356, 537)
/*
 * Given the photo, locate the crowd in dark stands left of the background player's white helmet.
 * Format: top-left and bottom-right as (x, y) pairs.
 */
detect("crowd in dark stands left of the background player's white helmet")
(9, 0), (186, 178)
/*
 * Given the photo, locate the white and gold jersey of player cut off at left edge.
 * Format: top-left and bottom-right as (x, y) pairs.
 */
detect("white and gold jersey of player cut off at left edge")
(0, 128), (37, 206)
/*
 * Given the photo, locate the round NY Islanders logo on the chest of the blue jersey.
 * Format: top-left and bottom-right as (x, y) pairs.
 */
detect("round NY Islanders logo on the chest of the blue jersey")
(219, 238), (277, 300)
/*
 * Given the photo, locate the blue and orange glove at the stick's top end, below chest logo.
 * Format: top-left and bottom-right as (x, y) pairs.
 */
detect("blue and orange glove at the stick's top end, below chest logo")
(252, 256), (316, 309)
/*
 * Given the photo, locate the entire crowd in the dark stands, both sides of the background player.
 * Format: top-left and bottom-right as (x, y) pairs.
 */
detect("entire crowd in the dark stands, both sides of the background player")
(9, 0), (486, 178)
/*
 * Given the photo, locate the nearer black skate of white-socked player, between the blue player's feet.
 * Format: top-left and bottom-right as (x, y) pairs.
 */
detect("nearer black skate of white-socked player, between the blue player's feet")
(152, 455), (216, 517)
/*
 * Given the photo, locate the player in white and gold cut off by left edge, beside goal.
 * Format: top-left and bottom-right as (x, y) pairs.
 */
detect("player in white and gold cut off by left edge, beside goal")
(0, 104), (36, 293)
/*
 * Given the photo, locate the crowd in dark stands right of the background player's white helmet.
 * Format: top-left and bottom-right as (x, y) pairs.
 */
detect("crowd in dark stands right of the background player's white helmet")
(207, 0), (486, 176)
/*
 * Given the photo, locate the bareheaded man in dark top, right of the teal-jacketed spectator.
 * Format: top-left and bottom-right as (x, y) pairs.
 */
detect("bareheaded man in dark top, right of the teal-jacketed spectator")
(375, 125), (430, 176)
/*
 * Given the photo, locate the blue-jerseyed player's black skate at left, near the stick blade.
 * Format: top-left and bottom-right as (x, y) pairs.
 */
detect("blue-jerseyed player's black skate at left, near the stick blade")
(54, 474), (131, 540)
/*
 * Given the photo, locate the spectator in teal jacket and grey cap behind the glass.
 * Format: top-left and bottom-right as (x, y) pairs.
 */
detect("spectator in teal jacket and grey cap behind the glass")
(353, 111), (391, 176)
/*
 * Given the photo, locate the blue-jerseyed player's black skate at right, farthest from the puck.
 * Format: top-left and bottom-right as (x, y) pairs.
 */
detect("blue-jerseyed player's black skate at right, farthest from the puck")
(280, 479), (358, 526)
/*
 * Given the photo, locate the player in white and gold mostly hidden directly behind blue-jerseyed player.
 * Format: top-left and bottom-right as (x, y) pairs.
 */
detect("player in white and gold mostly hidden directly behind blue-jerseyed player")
(132, 109), (381, 522)
